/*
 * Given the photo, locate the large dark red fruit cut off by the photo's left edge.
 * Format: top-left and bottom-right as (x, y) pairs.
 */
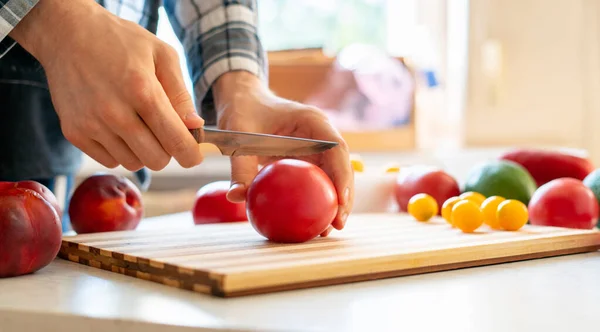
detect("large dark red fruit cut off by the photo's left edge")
(0, 186), (62, 277)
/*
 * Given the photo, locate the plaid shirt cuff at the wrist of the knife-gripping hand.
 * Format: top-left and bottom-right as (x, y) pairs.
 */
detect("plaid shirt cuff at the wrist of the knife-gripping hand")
(0, 0), (39, 58)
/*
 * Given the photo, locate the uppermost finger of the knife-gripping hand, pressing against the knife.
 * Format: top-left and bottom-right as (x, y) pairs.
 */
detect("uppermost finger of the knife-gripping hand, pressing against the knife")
(156, 46), (204, 129)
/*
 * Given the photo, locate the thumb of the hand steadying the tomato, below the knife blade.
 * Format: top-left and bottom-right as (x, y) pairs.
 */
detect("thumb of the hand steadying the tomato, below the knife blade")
(227, 156), (258, 203)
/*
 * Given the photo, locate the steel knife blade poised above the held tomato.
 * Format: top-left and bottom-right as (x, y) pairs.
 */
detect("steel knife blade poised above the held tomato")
(190, 128), (338, 157)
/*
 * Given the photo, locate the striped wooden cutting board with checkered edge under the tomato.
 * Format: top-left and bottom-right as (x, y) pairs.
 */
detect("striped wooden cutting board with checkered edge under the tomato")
(59, 214), (600, 297)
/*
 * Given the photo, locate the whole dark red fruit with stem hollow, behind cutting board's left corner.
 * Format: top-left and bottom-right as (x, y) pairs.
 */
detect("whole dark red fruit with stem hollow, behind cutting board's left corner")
(69, 174), (143, 234)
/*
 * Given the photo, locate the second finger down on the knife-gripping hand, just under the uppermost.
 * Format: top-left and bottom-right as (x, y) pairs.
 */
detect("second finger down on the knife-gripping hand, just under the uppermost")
(132, 71), (203, 168)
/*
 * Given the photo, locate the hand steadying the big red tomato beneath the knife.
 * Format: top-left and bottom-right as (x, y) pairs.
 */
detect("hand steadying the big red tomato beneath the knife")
(213, 71), (354, 236)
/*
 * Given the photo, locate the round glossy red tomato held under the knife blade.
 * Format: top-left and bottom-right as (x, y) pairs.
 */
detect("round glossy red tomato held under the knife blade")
(246, 159), (338, 243)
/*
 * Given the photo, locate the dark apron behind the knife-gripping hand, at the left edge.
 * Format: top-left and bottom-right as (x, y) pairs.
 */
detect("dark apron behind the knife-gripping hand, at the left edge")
(0, 40), (82, 231)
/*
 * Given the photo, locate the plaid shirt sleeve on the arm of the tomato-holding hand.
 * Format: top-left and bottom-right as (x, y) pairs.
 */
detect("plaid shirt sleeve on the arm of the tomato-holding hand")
(164, 0), (268, 124)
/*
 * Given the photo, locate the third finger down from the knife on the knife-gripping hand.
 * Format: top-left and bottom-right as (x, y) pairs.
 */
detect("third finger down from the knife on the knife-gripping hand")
(107, 112), (171, 171)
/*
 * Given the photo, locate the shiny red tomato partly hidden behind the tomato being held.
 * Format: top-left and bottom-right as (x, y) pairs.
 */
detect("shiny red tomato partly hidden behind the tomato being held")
(192, 181), (248, 225)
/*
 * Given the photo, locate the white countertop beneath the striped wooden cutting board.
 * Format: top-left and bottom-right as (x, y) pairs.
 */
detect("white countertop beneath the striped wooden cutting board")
(0, 215), (600, 332)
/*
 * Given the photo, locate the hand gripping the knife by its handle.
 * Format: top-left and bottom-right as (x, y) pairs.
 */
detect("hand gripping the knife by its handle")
(11, 0), (204, 171)
